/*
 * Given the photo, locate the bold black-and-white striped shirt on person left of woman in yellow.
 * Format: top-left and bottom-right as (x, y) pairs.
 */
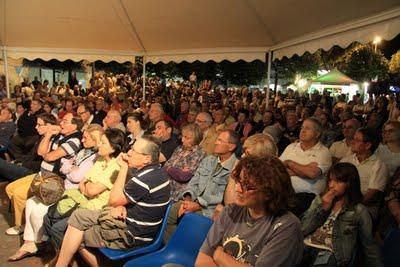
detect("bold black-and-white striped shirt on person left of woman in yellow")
(40, 132), (82, 174)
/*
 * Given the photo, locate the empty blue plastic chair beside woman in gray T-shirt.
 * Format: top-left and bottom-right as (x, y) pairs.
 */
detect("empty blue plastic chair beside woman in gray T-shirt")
(124, 213), (213, 267)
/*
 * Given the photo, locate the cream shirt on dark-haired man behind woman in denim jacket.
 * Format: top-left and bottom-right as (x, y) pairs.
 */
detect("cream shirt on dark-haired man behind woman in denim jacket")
(340, 154), (389, 194)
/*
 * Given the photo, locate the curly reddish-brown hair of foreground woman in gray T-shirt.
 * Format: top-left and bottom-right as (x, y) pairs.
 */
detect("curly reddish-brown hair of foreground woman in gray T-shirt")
(232, 155), (294, 215)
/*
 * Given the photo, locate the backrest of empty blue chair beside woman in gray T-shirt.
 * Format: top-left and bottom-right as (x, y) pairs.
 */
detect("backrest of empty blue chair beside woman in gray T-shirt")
(166, 213), (213, 259)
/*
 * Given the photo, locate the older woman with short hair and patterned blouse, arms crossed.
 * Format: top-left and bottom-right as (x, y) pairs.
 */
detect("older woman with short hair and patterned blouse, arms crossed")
(164, 124), (206, 201)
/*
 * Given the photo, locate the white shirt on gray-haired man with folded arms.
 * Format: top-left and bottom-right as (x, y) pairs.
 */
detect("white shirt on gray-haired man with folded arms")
(280, 142), (332, 194)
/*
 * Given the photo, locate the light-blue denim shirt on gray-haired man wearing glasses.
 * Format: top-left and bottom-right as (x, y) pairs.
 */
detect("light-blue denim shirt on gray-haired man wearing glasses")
(181, 154), (237, 217)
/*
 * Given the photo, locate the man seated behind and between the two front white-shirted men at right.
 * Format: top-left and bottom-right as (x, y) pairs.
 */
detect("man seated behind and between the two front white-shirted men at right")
(329, 119), (361, 162)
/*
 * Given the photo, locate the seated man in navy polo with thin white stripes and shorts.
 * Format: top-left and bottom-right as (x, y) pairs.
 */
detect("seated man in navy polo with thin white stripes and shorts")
(56, 137), (170, 267)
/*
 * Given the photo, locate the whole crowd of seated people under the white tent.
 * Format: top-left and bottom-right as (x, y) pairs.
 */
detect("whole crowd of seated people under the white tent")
(0, 73), (400, 266)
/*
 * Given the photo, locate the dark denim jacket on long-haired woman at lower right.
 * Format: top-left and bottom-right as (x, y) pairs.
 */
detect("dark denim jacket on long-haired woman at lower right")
(301, 196), (383, 267)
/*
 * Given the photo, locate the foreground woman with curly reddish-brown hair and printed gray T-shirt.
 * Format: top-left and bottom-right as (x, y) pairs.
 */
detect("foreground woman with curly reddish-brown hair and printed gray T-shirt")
(196, 156), (303, 267)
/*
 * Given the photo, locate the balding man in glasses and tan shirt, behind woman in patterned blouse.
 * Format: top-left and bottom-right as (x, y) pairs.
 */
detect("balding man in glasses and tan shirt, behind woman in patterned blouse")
(196, 112), (218, 155)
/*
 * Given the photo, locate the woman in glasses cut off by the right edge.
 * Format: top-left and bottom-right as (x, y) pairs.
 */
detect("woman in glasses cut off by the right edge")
(375, 121), (400, 177)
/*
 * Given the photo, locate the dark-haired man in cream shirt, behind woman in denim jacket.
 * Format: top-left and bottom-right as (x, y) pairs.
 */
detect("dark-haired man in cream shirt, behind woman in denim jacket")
(340, 127), (389, 221)
